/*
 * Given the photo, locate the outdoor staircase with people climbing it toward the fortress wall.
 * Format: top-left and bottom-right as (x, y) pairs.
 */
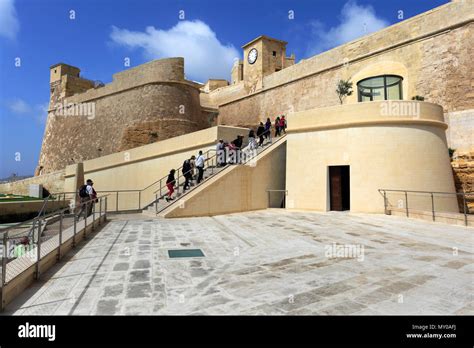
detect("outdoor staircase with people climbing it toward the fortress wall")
(142, 135), (285, 217)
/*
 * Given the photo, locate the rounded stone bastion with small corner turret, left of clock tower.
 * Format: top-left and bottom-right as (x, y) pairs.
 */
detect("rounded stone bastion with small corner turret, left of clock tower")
(39, 58), (213, 177)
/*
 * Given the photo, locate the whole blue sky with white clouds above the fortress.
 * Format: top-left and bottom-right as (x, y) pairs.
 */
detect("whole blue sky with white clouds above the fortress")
(0, 0), (449, 178)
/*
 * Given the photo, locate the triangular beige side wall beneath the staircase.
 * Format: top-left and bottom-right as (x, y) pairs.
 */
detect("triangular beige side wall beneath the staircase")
(158, 137), (286, 218)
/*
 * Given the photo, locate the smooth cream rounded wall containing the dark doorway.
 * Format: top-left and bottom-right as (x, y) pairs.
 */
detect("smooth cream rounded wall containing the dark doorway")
(286, 102), (458, 213)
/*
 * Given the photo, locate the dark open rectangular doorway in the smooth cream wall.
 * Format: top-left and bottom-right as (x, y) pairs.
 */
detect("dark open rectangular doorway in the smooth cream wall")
(329, 166), (351, 211)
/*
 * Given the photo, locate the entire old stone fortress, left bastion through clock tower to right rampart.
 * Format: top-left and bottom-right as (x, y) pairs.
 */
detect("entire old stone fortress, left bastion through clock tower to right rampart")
(29, 1), (474, 193)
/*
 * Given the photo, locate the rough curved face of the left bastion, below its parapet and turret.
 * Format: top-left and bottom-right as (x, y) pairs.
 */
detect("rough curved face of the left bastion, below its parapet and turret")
(39, 81), (209, 173)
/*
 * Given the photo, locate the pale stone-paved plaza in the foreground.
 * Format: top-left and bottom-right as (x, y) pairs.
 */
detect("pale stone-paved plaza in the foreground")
(6, 210), (474, 315)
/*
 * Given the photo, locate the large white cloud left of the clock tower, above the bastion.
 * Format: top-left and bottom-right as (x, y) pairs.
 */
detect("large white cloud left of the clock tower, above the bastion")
(110, 20), (240, 82)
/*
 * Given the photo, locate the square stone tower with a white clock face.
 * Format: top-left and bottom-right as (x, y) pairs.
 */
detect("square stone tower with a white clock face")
(242, 36), (295, 91)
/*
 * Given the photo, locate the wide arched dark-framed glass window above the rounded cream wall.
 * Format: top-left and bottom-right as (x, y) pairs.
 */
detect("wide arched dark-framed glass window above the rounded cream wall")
(357, 75), (403, 102)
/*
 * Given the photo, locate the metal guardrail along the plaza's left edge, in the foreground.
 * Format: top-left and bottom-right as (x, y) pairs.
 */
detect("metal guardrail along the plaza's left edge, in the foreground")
(0, 195), (107, 309)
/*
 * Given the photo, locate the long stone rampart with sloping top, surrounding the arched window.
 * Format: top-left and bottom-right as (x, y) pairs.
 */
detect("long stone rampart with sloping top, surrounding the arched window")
(213, 1), (474, 150)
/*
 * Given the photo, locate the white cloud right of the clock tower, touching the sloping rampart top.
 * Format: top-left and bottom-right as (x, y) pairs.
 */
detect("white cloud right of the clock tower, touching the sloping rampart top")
(308, 0), (390, 55)
